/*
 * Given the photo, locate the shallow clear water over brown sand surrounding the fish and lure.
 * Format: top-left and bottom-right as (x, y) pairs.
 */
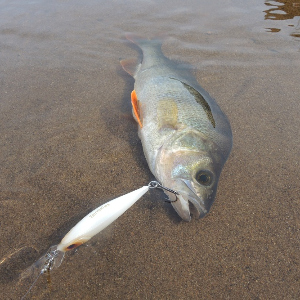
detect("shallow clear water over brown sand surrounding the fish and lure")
(0, 0), (300, 299)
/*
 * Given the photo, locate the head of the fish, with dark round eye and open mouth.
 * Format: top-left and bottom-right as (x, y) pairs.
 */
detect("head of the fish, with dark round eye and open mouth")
(156, 130), (224, 221)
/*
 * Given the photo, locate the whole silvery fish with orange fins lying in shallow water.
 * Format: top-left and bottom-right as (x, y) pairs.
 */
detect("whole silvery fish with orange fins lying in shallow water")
(120, 34), (232, 221)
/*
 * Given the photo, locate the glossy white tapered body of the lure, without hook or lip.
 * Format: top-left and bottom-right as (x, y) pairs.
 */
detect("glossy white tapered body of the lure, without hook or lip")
(57, 186), (149, 252)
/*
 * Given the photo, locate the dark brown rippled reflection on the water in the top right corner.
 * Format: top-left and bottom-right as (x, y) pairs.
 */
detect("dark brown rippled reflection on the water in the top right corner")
(264, 0), (300, 38)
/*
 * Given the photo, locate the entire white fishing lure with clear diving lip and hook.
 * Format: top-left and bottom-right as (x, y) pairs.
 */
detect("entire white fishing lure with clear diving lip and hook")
(21, 181), (179, 300)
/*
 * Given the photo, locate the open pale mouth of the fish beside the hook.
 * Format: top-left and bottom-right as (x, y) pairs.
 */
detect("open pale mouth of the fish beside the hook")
(172, 179), (208, 222)
